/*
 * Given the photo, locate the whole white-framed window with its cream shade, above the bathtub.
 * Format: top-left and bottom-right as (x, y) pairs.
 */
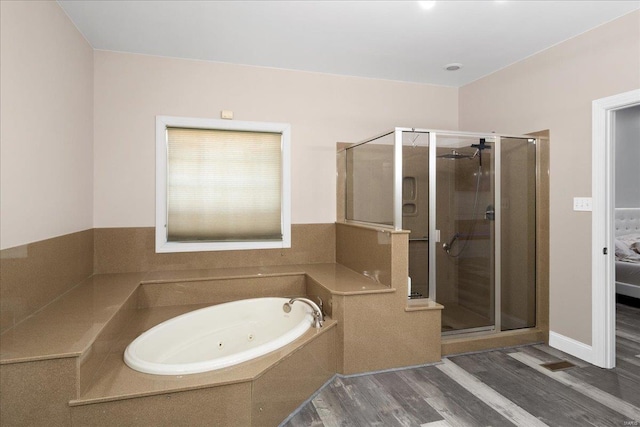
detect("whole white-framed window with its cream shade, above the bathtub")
(156, 116), (291, 252)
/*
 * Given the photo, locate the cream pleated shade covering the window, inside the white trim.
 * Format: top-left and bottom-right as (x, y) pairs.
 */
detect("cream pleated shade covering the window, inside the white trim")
(167, 127), (282, 242)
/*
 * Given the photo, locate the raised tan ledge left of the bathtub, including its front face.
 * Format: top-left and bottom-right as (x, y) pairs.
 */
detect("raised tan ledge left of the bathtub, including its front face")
(0, 273), (144, 425)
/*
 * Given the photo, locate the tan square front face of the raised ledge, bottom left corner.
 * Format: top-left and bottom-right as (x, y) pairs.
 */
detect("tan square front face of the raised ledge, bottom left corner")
(0, 358), (76, 427)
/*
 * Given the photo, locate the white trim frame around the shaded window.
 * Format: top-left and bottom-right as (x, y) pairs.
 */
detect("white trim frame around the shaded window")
(156, 116), (291, 253)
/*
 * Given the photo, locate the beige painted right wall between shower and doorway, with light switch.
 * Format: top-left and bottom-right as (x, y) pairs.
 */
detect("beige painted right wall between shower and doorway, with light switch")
(459, 12), (640, 345)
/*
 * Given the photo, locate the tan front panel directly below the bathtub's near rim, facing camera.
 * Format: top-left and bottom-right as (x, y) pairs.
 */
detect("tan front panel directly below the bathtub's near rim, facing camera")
(71, 383), (251, 427)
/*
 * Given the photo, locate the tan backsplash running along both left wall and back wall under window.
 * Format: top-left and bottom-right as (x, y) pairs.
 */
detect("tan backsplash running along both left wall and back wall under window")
(0, 224), (335, 333)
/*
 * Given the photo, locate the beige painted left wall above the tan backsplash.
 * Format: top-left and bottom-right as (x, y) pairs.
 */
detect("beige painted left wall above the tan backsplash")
(0, 1), (93, 249)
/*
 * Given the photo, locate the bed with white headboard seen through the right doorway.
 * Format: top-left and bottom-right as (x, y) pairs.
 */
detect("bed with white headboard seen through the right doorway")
(615, 208), (640, 298)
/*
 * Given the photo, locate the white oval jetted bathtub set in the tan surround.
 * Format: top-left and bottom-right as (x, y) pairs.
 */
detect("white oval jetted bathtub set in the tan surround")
(124, 298), (313, 375)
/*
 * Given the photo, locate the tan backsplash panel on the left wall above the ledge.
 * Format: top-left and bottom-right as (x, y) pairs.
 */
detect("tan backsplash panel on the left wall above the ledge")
(0, 230), (93, 331)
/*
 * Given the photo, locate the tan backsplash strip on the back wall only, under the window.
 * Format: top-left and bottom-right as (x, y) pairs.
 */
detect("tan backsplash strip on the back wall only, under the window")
(94, 224), (335, 273)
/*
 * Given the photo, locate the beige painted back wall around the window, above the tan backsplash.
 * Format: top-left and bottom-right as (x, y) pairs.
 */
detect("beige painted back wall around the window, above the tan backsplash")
(94, 51), (458, 227)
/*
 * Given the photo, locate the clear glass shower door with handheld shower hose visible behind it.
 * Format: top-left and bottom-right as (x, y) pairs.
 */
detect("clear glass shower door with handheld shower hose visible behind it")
(431, 133), (496, 334)
